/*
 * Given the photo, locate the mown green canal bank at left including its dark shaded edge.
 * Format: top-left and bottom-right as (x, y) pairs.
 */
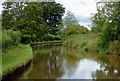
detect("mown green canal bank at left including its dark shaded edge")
(1, 44), (33, 80)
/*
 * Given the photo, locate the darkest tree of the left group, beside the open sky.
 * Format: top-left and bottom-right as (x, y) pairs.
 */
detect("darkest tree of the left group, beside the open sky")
(41, 2), (65, 35)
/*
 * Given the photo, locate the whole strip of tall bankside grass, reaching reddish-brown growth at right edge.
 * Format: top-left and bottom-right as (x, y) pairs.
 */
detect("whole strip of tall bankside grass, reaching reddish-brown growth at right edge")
(63, 33), (120, 55)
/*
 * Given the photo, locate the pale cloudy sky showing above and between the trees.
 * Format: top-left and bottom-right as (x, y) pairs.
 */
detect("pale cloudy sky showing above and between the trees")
(0, 0), (97, 29)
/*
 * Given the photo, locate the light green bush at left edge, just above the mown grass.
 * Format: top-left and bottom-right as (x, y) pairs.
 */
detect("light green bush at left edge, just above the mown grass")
(2, 30), (22, 50)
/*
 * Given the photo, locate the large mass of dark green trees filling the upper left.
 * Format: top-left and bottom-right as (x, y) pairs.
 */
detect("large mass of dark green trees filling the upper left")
(2, 2), (65, 43)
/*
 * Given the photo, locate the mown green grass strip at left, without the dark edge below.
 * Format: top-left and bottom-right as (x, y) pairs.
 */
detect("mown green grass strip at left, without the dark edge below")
(2, 44), (32, 76)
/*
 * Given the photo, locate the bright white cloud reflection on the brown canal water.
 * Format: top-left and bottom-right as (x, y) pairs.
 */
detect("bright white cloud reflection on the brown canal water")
(61, 59), (100, 79)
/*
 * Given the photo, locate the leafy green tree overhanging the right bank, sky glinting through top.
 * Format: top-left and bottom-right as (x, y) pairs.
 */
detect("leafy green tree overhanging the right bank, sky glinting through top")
(92, 2), (120, 48)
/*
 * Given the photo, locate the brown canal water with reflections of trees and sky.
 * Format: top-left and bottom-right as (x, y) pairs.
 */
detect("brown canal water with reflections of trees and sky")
(14, 45), (120, 79)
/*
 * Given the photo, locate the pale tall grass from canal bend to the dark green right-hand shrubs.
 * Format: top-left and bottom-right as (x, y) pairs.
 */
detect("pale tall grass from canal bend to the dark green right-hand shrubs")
(63, 34), (99, 51)
